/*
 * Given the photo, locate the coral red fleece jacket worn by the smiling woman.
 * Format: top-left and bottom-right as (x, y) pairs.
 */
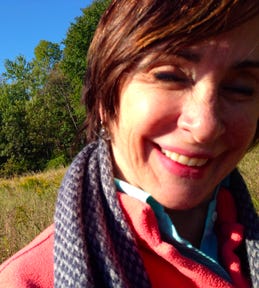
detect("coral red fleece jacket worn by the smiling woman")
(0, 190), (249, 288)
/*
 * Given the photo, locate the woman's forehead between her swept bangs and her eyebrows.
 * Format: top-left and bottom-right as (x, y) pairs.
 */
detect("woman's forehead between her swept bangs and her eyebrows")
(129, 17), (259, 75)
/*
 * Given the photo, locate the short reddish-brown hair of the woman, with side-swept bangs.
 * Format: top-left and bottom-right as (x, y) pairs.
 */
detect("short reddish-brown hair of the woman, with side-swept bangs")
(83, 0), (259, 142)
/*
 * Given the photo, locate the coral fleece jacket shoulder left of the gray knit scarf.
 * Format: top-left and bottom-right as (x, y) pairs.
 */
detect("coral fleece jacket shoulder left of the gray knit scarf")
(0, 225), (54, 288)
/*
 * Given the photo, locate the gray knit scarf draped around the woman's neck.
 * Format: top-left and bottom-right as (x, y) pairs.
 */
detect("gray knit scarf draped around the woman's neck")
(54, 139), (259, 288)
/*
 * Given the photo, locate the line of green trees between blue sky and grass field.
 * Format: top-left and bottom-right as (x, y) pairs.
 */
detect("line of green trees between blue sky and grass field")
(0, 0), (110, 177)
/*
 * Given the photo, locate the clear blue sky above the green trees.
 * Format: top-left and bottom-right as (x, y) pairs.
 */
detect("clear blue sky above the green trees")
(0, 0), (92, 74)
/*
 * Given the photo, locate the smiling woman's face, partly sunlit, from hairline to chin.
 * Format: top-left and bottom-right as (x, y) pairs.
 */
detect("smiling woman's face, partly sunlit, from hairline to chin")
(111, 19), (259, 209)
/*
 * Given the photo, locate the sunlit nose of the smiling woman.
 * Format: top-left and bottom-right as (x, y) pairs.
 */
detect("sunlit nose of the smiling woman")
(178, 85), (225, 143)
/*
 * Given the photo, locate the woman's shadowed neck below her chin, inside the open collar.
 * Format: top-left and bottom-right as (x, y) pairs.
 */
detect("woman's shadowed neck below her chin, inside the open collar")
(166, 202), (208, 248)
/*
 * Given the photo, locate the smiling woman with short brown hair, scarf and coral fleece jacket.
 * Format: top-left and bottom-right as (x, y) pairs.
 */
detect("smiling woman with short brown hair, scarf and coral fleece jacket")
(0, 0), (259, 287)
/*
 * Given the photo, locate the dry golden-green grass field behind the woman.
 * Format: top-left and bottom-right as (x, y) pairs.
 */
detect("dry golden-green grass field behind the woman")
(0, 147), (259, 263)
